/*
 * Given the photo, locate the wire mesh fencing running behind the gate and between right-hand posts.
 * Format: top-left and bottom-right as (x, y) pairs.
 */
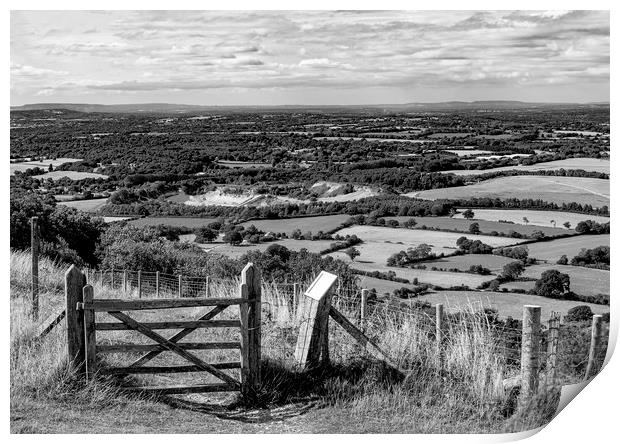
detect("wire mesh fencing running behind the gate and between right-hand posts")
(32, 270), (609, 385)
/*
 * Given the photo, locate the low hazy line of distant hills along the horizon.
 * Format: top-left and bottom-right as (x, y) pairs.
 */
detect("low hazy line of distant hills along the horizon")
(11, 100), (609, 114)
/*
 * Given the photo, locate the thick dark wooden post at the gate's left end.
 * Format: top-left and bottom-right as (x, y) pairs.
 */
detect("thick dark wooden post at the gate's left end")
(65, 265), (86, 373)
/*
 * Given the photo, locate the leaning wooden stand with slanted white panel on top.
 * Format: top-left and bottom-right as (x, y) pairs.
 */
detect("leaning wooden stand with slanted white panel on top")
(295, 271), (338, 369)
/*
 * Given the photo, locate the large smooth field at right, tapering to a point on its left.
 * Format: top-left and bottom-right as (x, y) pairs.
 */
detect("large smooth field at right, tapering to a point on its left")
(405, 176), (609, 207)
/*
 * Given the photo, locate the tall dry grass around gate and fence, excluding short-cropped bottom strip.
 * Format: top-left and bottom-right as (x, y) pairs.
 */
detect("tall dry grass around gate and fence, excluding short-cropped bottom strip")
(11, 252), (549, 433)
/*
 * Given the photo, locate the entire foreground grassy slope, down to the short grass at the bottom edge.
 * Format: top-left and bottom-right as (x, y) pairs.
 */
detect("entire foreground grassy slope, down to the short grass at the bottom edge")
(11, 253), (560, 433)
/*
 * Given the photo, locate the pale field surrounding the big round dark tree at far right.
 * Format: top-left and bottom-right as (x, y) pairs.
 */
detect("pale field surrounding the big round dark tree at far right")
(502, 264), (610, 296)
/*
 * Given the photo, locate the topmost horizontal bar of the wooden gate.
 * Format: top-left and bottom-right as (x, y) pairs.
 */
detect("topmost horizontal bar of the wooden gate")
(84, 298), (251, 311)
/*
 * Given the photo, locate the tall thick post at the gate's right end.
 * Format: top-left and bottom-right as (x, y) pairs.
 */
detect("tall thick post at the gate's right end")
(239, 262), (261, 395)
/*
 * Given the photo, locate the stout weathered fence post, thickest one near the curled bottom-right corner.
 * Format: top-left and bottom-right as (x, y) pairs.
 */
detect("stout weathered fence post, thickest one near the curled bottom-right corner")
(520, 305), (541, 405)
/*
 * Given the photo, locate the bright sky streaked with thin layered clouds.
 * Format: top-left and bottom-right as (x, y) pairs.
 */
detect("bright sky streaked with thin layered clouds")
(10, 11), (610, 106)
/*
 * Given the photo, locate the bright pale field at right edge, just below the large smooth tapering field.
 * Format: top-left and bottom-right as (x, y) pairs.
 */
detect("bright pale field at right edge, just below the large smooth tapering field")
(453, 208), (609, 229)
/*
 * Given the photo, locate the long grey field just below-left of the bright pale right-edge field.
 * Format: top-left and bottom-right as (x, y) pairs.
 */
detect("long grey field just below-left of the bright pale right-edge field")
(385, 216), (568, 236)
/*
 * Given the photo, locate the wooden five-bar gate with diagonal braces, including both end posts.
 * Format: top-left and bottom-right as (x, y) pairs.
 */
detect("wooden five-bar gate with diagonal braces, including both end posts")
(65, 264), (261, 395)
